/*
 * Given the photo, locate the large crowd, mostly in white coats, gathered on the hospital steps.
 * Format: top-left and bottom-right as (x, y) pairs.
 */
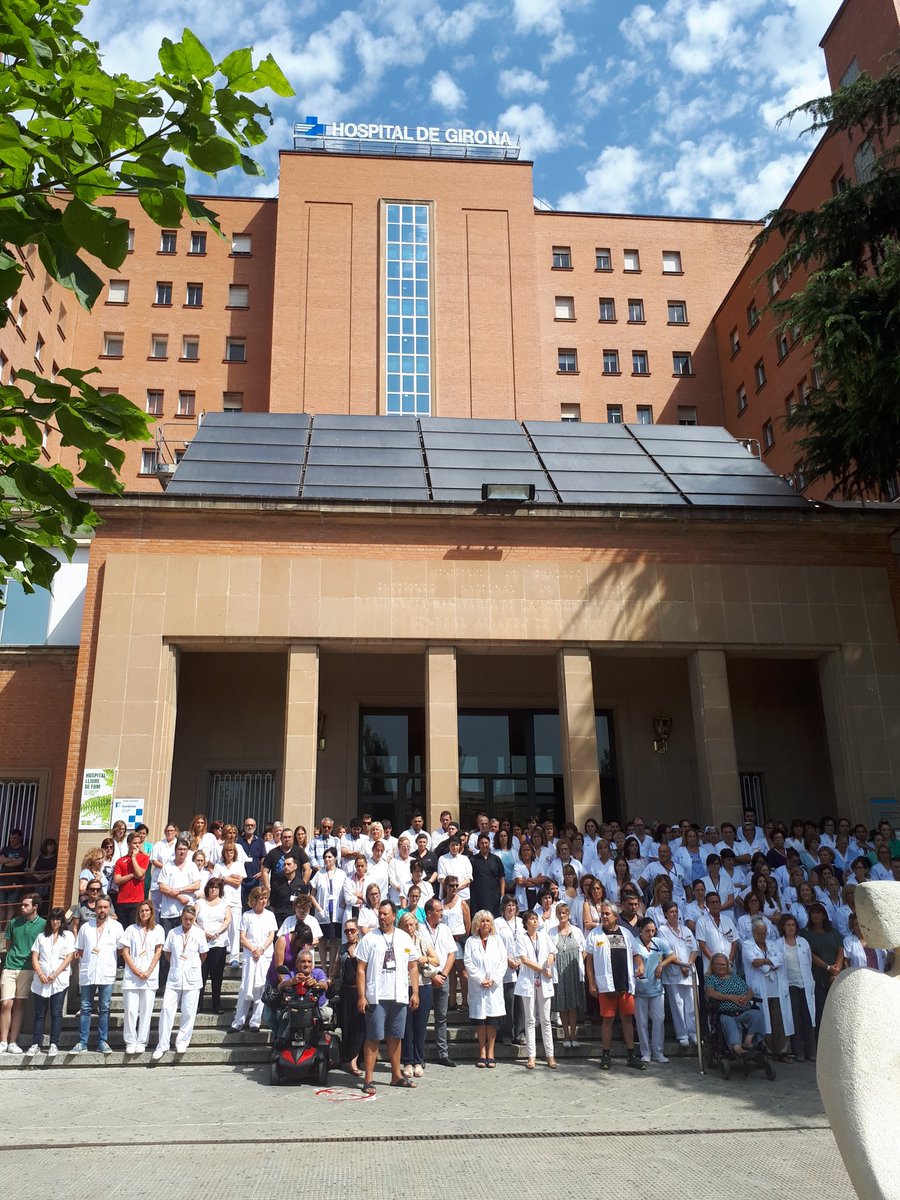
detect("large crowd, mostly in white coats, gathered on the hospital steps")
(0, 811), (900, 1091)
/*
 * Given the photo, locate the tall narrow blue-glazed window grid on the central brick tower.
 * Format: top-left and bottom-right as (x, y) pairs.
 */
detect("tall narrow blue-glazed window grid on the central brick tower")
(383, 203), (432, 416)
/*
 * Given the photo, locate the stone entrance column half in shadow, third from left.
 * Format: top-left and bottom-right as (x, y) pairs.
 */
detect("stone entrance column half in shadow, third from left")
(557, 647), (602, 829)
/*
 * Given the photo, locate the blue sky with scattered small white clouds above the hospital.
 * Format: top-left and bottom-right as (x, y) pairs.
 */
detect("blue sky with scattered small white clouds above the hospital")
(84, 0), (840, 218)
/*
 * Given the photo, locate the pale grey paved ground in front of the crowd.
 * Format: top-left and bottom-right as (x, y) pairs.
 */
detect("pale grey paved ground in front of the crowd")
(0, 1061), (853, 1200)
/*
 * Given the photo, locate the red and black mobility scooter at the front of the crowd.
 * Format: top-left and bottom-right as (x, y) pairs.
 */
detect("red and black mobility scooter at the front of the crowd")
(269, 986), (341, 1087)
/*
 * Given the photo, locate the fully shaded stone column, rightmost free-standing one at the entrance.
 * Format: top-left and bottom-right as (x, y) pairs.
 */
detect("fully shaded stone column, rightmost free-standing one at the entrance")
(689, 650), (742, 826)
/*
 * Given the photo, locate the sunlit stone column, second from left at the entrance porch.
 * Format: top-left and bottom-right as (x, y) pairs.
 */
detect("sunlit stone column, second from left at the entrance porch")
(425, 646), (460, 830)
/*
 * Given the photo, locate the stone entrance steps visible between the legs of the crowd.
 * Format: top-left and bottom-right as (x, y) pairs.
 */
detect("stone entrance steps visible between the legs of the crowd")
(0, 968), (696, 1078)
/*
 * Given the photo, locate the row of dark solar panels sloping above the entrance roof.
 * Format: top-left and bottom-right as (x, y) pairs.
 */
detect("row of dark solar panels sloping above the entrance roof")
(166, 413), (809, 508)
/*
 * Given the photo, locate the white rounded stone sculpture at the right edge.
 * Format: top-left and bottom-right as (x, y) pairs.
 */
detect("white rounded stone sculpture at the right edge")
(816, 882), (900, 1200)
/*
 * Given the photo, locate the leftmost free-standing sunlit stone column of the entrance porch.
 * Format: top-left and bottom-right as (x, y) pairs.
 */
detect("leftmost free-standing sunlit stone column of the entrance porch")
(281, 644), (319, 835)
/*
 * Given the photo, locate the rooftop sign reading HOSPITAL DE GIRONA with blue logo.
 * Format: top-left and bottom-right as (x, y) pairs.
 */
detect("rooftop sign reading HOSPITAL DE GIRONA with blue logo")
(294, 116), (518, 158)
